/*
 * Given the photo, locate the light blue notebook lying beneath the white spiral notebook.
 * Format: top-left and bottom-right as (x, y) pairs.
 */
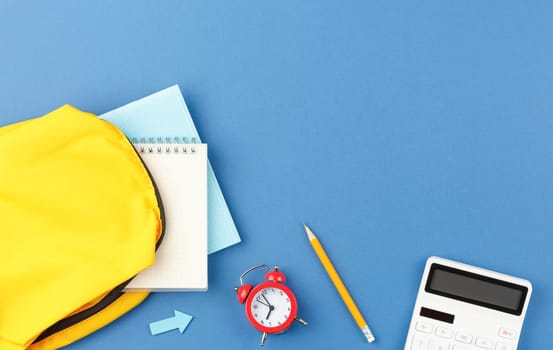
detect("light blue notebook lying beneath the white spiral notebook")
(99, 85), (240, 254)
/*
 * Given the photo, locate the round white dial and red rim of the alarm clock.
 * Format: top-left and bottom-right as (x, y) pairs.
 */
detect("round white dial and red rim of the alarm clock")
(246, 282), (297, 334)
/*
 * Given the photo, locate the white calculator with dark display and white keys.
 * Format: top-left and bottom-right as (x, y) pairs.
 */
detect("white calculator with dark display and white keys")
(404, 256), (532, 350)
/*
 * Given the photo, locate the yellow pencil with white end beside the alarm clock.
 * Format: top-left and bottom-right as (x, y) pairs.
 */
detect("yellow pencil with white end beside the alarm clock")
(303, 224), (375, 343)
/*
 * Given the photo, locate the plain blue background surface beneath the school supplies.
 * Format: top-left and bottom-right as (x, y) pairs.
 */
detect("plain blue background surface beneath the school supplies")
(0, 0), (553, 350)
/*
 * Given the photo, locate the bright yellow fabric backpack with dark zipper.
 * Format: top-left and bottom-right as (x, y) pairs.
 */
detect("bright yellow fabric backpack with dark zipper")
(0, 106), (163, 350)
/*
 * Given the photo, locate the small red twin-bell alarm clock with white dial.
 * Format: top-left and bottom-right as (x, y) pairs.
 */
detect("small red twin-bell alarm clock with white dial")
(234, 265), (307, 346)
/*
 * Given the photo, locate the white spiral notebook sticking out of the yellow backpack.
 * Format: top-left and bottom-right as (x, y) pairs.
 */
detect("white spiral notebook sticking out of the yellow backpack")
(125, 138), (207, 292)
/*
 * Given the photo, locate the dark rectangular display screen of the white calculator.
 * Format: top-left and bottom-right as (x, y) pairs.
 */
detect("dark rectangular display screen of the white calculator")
(425, 264), (528, 315)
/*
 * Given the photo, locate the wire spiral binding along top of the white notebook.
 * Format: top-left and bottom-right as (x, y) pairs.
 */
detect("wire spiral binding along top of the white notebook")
(131, 137), (197, 154)
